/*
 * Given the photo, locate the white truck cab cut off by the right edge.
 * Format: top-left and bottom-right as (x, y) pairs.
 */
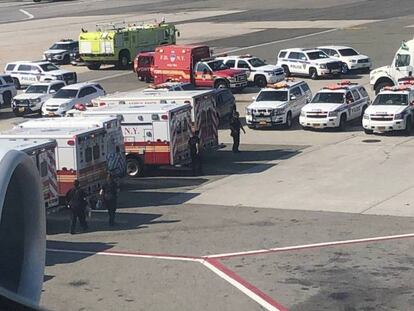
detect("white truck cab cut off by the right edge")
(370, 39), (414, 94)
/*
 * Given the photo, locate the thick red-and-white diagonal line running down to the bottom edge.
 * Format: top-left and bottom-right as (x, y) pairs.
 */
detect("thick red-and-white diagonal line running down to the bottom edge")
(203, 259), (288, 311)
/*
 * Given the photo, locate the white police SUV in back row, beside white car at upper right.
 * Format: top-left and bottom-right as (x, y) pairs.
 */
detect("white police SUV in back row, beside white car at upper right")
(277, 48), (342, 79)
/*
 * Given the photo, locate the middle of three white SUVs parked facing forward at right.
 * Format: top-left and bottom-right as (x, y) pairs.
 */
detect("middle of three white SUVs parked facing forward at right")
(299, 81), (370, 130)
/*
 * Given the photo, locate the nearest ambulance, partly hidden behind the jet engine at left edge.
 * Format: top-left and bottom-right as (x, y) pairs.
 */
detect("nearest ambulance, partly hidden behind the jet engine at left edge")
(0, 138), (59, 208)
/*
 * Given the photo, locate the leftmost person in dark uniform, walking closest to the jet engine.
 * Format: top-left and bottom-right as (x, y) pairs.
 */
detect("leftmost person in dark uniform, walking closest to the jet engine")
(66, 180), (88, 234)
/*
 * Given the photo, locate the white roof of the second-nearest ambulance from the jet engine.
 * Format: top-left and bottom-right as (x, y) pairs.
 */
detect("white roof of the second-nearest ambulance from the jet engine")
(0, 125), (104, 139)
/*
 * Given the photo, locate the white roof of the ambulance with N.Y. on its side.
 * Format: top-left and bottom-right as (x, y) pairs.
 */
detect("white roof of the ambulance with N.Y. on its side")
(76, 104), (191, 115)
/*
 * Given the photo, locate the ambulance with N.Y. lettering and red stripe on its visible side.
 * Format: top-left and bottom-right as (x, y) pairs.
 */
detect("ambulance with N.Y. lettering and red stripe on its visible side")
(73, 104), (192, 177)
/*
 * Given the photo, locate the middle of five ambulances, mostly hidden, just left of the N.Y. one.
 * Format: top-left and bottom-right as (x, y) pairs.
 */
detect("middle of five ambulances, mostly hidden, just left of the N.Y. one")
(19, 116), (126, 177)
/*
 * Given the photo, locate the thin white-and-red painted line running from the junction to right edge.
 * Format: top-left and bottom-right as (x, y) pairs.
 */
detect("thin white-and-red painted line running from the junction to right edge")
(205, 233), (414, 259)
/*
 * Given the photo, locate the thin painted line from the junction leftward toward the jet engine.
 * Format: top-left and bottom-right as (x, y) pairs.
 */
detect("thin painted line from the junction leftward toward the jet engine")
(46, 248), (203, 263)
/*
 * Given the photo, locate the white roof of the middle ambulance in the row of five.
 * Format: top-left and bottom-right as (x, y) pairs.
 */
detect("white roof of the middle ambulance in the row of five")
(19, 116), (116, 128)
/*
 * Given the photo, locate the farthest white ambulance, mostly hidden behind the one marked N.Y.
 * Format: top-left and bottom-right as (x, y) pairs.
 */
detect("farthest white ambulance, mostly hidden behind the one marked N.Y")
(91, 90), (219, 150)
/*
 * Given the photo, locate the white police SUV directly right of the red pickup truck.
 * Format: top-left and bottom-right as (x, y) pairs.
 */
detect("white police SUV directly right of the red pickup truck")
(217, 55), (285, 87)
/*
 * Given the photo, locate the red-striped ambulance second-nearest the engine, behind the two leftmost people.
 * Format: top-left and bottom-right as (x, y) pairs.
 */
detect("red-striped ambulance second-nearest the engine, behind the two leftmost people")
(0, 125), (107, 199)
